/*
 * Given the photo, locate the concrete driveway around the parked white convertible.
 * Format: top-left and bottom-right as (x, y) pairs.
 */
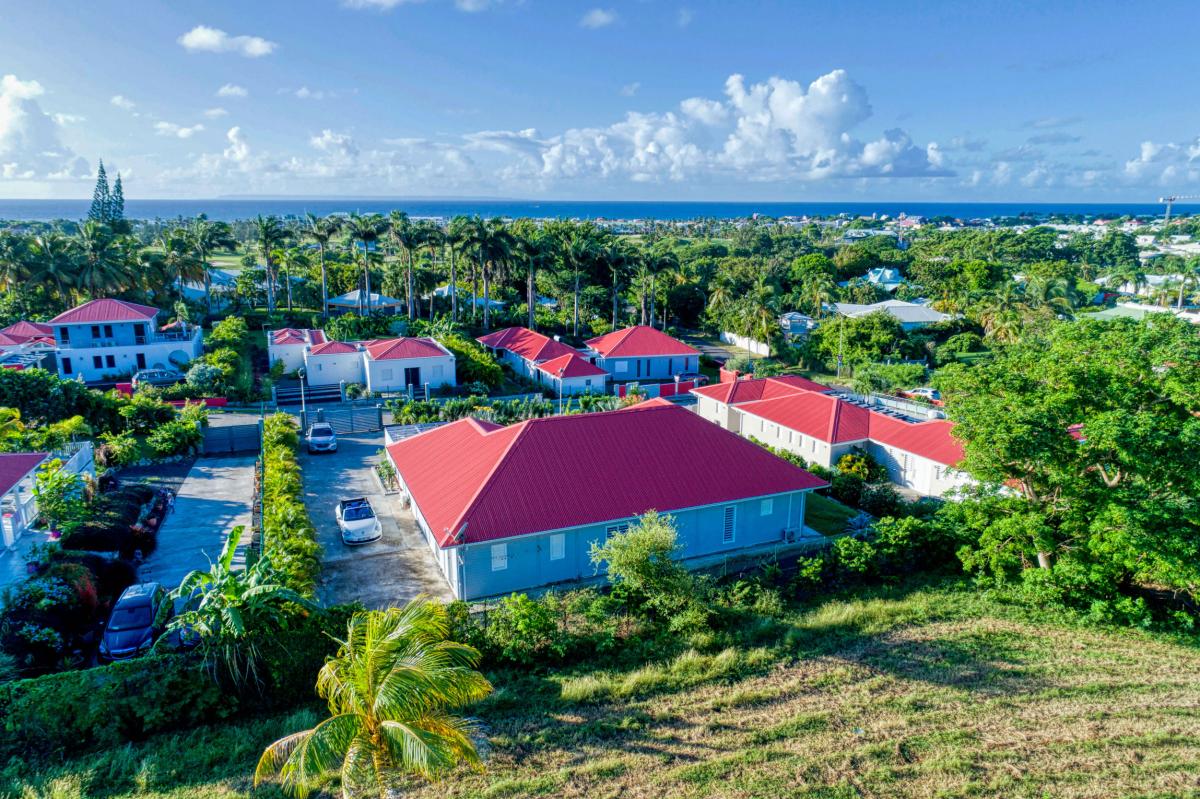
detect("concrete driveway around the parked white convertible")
(300, 432), (451, 608)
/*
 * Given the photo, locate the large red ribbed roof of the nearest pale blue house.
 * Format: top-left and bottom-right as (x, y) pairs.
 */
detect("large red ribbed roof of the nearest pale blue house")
(388, 402), (827, 547)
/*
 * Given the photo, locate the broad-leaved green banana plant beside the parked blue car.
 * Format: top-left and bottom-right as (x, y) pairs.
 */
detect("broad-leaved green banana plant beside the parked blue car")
(170, 527), (316, 684)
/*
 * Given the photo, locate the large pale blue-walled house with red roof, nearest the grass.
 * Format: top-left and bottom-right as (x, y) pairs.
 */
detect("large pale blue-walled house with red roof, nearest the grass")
(388, 400), (828, 600)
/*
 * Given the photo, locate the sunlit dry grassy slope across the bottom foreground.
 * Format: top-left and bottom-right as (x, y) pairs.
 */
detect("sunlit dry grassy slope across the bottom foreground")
(0, 584), (1200, 799)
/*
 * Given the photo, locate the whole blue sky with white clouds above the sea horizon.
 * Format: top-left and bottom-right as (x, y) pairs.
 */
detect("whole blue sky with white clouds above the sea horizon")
(0, 0), (1200, 202)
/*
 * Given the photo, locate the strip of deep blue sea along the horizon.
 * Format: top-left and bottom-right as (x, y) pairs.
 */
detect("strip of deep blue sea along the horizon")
(0, 198), (1186, 222)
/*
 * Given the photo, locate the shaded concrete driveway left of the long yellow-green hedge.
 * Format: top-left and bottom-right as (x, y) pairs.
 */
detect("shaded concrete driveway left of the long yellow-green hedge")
(139, 456), (254, 588)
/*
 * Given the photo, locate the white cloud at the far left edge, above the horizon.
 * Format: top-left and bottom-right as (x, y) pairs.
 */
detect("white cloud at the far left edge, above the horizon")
(0, 74), (89, 180)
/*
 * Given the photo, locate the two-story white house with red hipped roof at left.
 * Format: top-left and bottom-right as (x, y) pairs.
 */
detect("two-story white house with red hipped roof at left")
(47, 299), (203, 382)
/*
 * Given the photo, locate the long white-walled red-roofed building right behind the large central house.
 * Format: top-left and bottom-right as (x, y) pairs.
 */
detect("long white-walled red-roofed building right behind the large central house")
(691, 377), (972, 497)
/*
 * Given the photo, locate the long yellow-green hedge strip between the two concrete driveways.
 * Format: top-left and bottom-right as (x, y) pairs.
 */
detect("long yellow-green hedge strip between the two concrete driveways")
(263, 414), (320, 596)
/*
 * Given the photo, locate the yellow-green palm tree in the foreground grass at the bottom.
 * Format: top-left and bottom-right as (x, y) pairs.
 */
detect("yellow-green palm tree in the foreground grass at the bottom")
(254, 599), (492, 798)
